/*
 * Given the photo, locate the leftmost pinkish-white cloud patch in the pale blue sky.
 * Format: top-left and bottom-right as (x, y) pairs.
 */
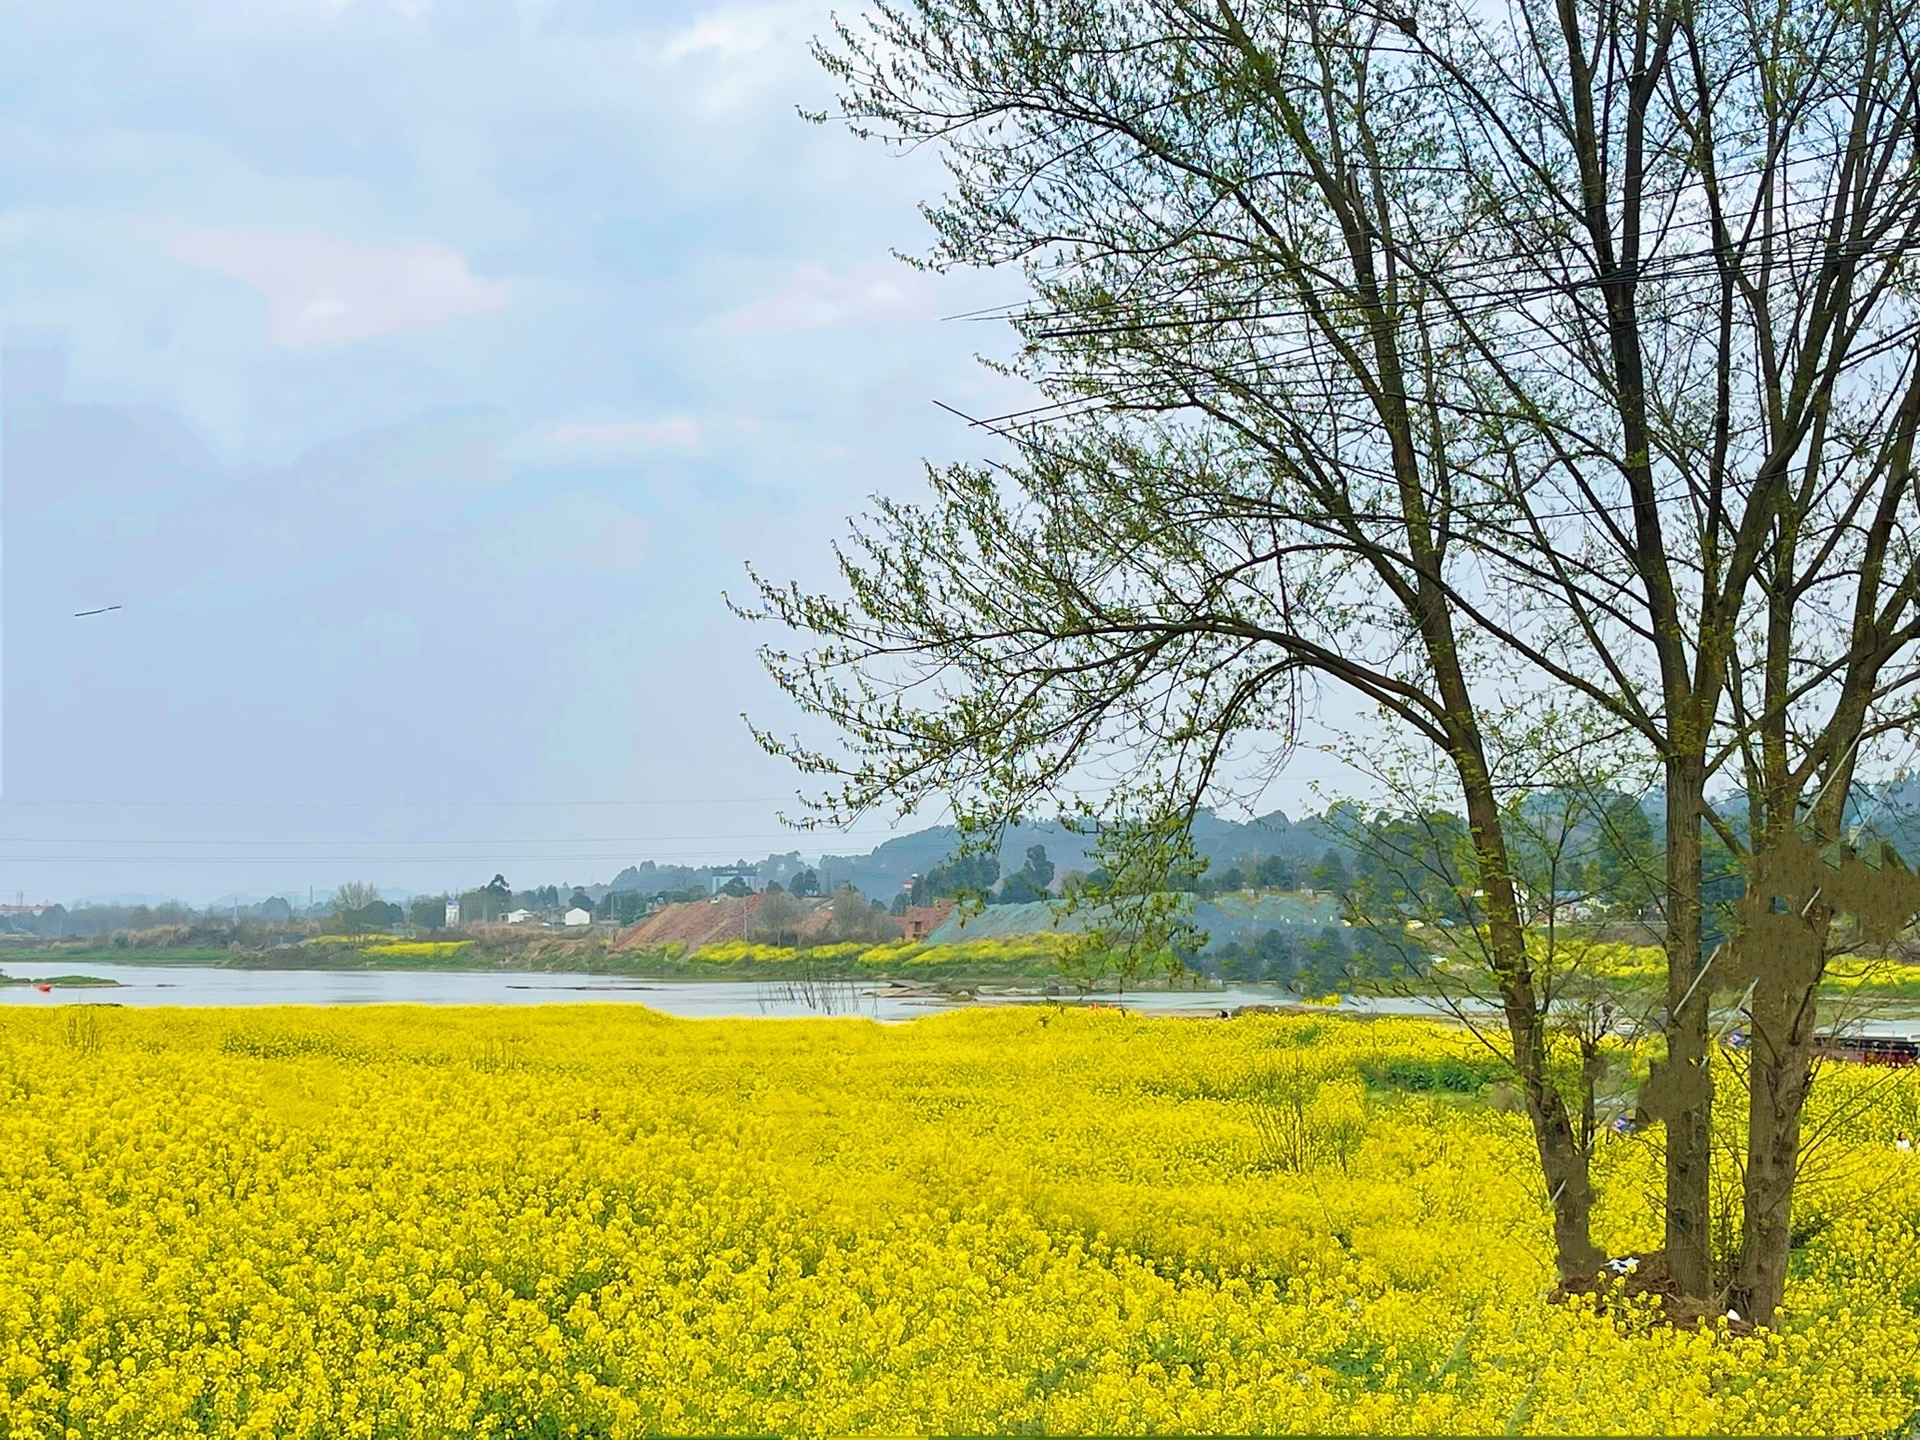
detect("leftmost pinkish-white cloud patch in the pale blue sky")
(167, 230), (509, 349)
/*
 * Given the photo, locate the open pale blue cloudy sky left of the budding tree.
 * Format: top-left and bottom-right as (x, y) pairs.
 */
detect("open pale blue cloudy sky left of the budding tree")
(0, 0), (1367, 902)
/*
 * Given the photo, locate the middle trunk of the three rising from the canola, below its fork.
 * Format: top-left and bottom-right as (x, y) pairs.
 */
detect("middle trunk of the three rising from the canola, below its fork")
(1661, 756), (1713, 1300)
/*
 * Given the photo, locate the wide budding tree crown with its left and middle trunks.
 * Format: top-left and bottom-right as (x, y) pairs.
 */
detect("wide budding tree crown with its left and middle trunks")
(741, 0), (1920, 1320)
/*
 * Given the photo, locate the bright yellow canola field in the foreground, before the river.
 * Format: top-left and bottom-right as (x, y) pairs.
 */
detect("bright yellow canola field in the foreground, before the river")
(0, 1006), (1920, 1440)
